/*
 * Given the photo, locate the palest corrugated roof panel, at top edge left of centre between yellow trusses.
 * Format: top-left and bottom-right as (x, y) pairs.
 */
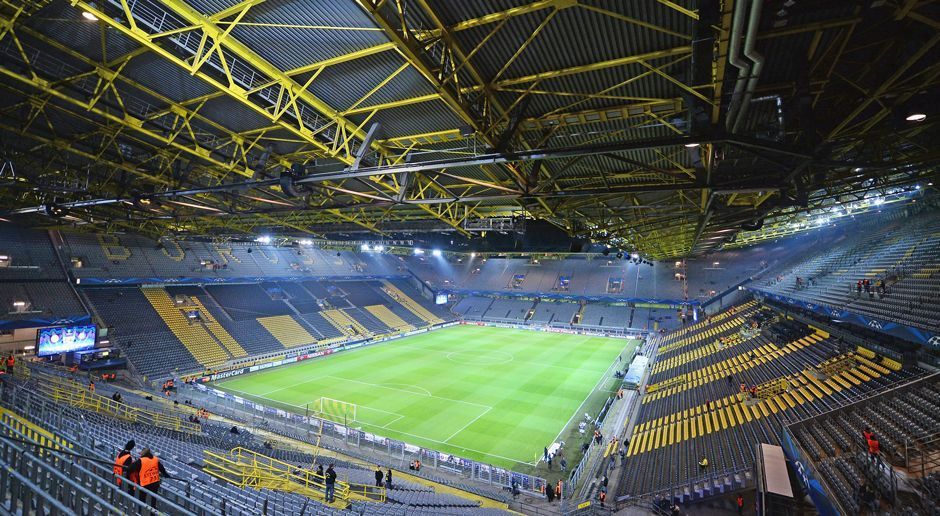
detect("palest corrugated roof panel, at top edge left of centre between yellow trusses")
(232, 0), (388, 71)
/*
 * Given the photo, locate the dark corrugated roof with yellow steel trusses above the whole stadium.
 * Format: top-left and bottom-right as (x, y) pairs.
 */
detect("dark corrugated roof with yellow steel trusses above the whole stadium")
(0, 0), (940, 258)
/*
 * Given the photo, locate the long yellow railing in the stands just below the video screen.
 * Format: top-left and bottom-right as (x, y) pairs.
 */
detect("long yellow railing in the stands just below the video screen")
(37, 376), (202, 433)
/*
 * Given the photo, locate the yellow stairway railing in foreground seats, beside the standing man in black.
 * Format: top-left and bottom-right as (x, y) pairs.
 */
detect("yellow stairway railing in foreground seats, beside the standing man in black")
(203, 447), (385, 504)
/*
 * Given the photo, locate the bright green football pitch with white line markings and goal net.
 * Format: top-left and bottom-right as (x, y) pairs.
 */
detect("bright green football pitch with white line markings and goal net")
(216, 325), (638, 468)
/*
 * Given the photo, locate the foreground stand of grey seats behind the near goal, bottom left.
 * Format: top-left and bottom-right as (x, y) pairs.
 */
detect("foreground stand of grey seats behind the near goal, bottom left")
(0, 367), (504, 516)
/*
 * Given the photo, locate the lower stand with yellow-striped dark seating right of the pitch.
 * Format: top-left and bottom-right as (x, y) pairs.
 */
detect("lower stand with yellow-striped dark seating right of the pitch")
(619, 301), (923, 502)
